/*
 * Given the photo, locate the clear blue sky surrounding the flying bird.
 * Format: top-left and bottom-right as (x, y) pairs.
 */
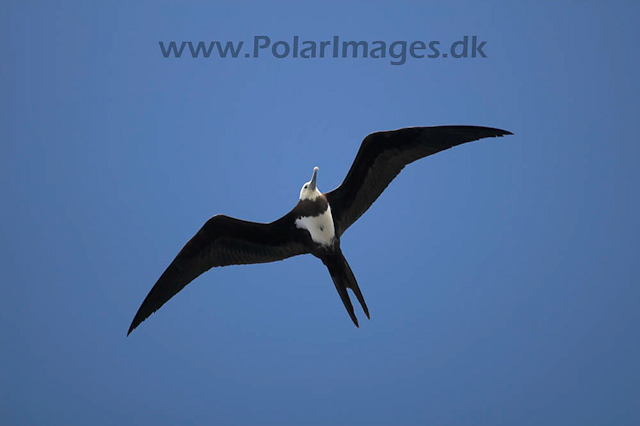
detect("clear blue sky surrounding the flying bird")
(0, 1), (640, 426)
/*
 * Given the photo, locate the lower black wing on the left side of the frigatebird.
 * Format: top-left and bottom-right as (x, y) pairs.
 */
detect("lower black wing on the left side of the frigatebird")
(127, 214), (307, 335)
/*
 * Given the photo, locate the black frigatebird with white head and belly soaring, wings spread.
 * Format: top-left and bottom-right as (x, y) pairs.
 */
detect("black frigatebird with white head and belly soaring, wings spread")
(127, 126), (512, 335)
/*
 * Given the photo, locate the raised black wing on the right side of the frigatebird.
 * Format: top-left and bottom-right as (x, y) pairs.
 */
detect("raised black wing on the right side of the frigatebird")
(325, 126), (513, 236)
